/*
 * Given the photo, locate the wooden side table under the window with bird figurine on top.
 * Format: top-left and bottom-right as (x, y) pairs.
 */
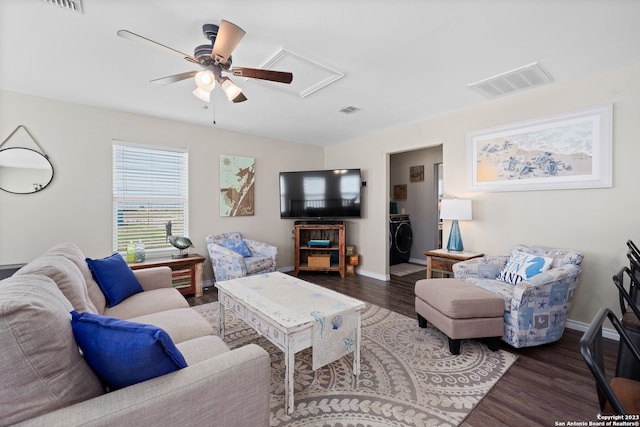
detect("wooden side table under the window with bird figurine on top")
(129, 254), (205, 297)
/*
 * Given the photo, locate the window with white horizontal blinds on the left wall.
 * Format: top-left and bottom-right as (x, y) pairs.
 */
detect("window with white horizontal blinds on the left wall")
(113, 141), (189, 252)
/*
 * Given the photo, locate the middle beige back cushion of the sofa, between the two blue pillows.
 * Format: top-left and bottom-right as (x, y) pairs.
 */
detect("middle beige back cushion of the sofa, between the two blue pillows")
(15, 255), (97, 313)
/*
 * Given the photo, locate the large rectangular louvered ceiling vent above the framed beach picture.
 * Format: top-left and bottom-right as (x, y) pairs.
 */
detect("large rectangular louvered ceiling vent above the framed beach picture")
(469, 62), (553, 98)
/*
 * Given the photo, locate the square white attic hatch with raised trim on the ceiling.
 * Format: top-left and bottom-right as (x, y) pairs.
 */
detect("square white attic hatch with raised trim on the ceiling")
(258, 49), (344, 98)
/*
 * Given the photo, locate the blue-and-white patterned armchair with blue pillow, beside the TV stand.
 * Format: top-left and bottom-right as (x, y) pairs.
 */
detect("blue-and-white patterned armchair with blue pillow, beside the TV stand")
(205, 232), (278, 281)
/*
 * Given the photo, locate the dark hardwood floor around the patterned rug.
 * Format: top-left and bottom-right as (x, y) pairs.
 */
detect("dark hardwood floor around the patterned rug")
(187, 272), (617, 427)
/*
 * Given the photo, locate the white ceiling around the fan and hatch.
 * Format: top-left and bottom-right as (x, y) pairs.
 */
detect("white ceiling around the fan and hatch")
(0, 0), (640, 145)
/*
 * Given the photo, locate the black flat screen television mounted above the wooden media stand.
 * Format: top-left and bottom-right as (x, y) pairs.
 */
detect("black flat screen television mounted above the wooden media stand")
(280, 169), (362, 219)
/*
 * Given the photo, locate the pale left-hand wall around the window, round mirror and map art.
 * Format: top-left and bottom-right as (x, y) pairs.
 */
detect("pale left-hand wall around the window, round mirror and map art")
(0, 91), (324, 280)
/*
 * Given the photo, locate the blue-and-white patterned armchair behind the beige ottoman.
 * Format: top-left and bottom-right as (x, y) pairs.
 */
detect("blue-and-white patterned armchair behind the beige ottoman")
(453, 245), (583, 348)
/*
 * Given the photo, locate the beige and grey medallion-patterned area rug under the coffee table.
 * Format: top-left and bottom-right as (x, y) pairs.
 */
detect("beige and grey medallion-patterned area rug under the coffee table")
(194, 302), (516, 427)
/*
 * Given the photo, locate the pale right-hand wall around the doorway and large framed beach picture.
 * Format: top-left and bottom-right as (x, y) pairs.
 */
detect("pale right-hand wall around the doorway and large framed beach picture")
(325, 66), (640, 323)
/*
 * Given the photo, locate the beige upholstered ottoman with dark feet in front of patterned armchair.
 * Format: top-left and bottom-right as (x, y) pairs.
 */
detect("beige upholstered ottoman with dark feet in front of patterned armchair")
(415, 279), (504, 354)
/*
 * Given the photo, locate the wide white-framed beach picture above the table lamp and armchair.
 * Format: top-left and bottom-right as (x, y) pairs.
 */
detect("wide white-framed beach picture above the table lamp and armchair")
(467, 105), (613, 192)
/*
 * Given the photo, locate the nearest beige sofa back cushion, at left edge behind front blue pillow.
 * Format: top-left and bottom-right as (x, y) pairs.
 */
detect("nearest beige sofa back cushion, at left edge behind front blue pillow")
(0, 274), (104, 425)
